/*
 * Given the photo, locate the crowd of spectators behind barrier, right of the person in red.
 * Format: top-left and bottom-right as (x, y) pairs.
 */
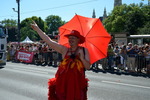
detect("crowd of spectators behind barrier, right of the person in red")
(92, 43), (150, 74)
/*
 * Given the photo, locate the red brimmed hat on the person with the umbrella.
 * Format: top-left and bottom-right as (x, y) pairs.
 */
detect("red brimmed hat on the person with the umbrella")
(64, 30), (85, 44)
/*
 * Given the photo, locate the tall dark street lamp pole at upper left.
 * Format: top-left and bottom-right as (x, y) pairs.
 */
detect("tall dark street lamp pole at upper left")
(12, 0), (20, 45)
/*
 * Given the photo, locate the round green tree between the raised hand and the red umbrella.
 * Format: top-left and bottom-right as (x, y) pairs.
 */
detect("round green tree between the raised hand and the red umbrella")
(45, 15), (65, 34)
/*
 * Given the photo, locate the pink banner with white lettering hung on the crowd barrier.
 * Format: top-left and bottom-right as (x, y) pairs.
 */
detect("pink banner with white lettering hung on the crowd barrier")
(16, 51), (34, 63)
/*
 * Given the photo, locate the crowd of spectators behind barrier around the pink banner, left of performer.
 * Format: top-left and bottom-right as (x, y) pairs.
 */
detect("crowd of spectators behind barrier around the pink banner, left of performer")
(7, 41), (61, 67)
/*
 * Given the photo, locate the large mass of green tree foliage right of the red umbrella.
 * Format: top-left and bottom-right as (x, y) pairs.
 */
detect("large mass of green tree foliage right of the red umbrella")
(103, 3), (150, 34)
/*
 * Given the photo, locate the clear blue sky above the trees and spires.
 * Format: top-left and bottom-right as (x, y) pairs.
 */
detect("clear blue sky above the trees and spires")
(0, 0), (148, 21)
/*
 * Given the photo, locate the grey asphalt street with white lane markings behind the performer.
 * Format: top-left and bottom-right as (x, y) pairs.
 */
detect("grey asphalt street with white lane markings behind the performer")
(0, 62), (150, 100)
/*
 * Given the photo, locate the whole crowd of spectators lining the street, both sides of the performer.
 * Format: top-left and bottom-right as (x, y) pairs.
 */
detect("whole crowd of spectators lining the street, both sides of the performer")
(7, 41), (150, 74)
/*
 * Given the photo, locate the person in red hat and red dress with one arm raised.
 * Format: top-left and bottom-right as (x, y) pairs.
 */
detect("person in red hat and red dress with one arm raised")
(31, 22), (91, 100)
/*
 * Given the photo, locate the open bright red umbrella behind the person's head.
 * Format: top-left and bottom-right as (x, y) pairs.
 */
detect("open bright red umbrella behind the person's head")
(59, 15), (111, 64)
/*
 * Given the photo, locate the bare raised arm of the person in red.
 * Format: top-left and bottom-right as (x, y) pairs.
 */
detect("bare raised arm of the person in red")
(31, 21), (67, 54)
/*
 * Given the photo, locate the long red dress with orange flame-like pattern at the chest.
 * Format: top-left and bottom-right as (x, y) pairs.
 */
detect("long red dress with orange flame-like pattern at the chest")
(48, 50), (88, 100)
